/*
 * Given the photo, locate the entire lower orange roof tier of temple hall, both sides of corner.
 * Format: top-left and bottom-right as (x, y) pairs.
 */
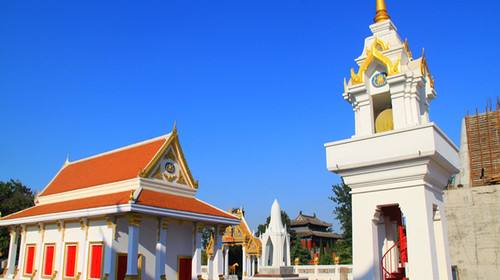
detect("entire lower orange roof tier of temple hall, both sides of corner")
(0, 190), (235, 220)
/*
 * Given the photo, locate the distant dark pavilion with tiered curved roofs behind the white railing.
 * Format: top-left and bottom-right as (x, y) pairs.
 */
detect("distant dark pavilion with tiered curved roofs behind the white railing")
(290, 211), (342, 259)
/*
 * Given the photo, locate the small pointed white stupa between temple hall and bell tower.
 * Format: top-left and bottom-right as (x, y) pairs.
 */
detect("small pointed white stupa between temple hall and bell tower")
(260, 200), (290, 268)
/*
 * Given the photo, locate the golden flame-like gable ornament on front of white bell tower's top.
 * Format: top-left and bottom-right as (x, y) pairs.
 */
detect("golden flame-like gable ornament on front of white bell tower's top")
(350, 37), (401, 87)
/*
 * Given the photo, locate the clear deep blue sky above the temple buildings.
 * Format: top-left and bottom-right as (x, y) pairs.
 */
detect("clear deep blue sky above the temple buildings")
(0, 0), (500, 231)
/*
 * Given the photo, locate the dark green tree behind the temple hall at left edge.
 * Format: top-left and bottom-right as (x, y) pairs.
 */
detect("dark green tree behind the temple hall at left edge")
(0, 180), (35, 257)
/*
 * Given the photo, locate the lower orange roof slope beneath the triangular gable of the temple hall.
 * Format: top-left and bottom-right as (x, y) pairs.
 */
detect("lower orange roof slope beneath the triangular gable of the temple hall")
(136, 190), (236, 219)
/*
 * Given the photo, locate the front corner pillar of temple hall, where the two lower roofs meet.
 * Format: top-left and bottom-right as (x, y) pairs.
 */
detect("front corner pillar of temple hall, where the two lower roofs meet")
(125, 214), (141, 280)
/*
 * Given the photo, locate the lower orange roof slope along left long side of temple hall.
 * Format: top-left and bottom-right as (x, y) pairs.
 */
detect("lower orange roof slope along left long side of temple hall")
(0, 191), (130, 220)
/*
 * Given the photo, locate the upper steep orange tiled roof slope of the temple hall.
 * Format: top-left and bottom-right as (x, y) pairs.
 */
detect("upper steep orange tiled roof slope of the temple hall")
(40, 137), (168, 196)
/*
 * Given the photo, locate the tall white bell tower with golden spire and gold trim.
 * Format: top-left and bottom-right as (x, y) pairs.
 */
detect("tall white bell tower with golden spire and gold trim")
(325, 0), (458, 280)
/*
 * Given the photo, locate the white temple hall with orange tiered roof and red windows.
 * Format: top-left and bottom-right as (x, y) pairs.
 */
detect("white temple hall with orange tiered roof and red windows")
(0, 127), (240, 280)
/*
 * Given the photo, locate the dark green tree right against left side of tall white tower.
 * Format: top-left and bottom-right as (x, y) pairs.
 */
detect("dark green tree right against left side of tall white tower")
(329, 181), (352, 264)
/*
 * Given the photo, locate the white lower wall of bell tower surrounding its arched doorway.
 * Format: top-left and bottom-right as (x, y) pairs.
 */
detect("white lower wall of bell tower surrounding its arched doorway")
(352, 186), (445, 280)
